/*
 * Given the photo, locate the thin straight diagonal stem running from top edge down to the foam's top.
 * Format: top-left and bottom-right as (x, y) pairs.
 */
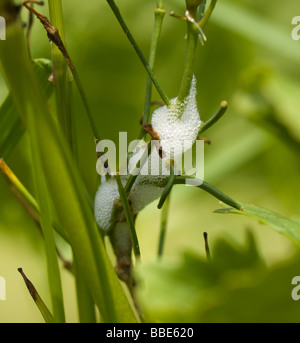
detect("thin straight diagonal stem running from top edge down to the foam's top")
(107, 0), (170, 106)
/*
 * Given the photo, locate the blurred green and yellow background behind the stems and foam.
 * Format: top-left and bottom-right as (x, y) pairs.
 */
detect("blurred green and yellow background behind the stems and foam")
(0, 0), (300, 322)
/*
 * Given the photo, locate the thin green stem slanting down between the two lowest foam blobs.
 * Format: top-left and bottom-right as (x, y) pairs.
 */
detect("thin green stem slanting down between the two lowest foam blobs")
(116, 174), (141, 259)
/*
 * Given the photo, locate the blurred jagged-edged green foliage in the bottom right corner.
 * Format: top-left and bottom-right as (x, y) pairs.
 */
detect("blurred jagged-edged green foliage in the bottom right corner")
(137, 234), (299, 323)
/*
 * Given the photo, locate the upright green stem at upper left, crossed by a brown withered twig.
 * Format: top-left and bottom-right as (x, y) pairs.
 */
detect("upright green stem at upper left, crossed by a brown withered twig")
(48, 0), (72, 148)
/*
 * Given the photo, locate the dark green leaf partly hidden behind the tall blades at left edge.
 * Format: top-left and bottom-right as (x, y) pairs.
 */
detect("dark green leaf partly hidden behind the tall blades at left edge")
(0, 59), (54, 158)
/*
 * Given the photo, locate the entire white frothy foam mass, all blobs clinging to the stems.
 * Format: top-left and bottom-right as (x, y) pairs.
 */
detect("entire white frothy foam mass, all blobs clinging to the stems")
(94, 77), (202, 232)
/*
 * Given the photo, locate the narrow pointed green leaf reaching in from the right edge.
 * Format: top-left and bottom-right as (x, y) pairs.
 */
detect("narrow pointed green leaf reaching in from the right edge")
(215, 203), (300, 245)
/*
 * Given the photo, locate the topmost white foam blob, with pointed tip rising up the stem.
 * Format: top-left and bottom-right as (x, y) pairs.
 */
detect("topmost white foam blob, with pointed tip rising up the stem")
(151, 76), (202, 156)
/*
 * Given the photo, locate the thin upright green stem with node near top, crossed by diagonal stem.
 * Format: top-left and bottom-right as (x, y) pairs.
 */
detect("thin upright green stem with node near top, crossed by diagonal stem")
(142, 5), (166, 127)
